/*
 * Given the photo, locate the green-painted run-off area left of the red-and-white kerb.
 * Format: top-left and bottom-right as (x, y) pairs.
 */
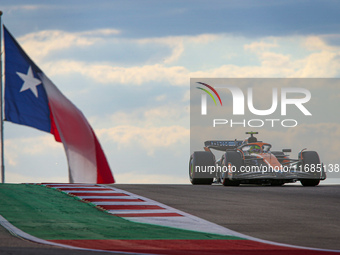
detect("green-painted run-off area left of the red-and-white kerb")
(0, 184), (241, 240)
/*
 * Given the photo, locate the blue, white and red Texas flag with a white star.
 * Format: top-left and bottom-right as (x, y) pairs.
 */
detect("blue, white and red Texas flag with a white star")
(4, 27), (114, 183)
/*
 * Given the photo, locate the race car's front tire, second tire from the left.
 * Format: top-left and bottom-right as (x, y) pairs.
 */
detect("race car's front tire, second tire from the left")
(222, 151), (243, 186)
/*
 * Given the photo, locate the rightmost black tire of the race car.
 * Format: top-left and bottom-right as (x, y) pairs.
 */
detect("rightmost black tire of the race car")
(300, 151), (321, 186)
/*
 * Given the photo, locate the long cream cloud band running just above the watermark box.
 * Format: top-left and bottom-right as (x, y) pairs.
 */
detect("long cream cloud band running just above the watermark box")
(41, 42), (340, 86)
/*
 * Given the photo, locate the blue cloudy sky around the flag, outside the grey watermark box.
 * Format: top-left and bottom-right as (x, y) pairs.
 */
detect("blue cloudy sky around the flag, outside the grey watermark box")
(0, 0), (340, 183)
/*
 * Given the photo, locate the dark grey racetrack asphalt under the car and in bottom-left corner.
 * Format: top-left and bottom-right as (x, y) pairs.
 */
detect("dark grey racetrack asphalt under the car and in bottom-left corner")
(0, 184), (340, 255)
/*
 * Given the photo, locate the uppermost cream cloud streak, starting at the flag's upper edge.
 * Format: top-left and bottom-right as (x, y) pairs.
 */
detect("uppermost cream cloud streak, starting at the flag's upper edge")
(18, 28), (215, 64)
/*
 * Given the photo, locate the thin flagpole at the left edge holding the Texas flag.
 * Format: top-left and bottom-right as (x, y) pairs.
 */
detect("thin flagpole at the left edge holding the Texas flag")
(0, 10), (5, 183)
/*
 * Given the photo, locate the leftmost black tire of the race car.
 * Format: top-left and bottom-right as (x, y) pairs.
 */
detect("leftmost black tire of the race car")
(189, 151), (215, 185)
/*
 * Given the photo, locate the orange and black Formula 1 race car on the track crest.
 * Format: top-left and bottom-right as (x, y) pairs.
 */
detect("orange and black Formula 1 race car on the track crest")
(189, 132), (326, 186)
